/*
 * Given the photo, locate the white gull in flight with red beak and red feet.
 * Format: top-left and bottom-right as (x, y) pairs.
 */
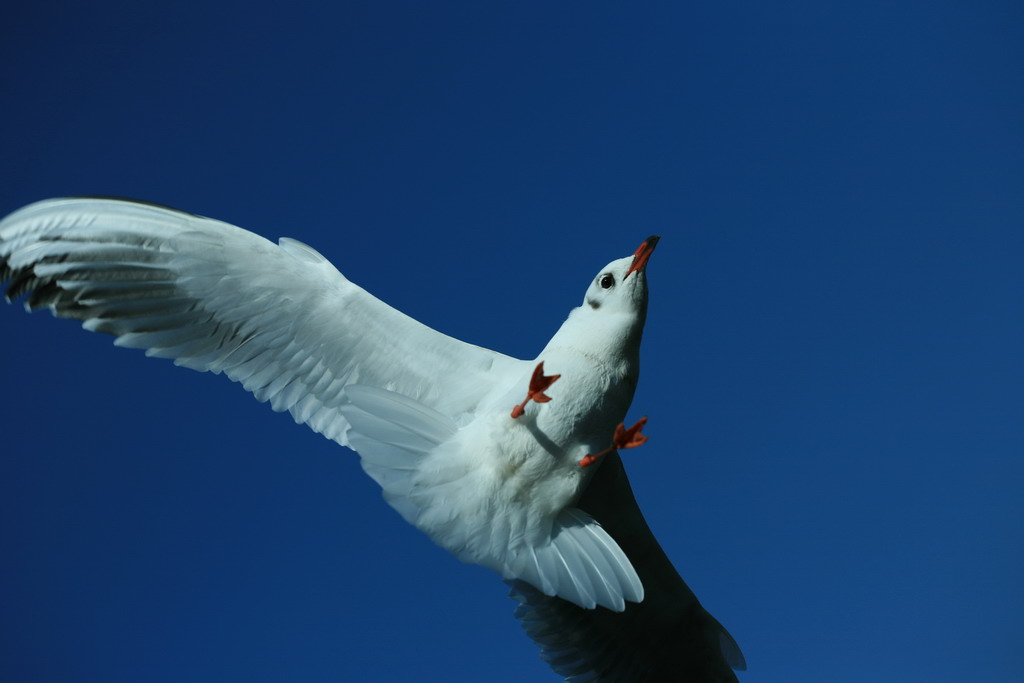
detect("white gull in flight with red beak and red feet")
(0, 198), (745, 683)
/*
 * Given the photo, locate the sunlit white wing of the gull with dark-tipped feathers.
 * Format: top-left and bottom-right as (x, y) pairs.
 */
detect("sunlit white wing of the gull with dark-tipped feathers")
(0, 198), (522, 445)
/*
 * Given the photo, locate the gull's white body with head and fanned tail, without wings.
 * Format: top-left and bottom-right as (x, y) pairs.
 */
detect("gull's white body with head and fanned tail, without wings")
(341, 243), (653, 610)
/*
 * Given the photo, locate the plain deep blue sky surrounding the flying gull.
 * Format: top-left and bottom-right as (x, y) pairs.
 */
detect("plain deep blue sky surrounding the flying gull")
(0, 0), (1024, 683)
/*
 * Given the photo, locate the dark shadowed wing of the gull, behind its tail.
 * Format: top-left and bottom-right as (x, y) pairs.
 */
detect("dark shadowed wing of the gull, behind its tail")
(509, 454), (746, 683)
